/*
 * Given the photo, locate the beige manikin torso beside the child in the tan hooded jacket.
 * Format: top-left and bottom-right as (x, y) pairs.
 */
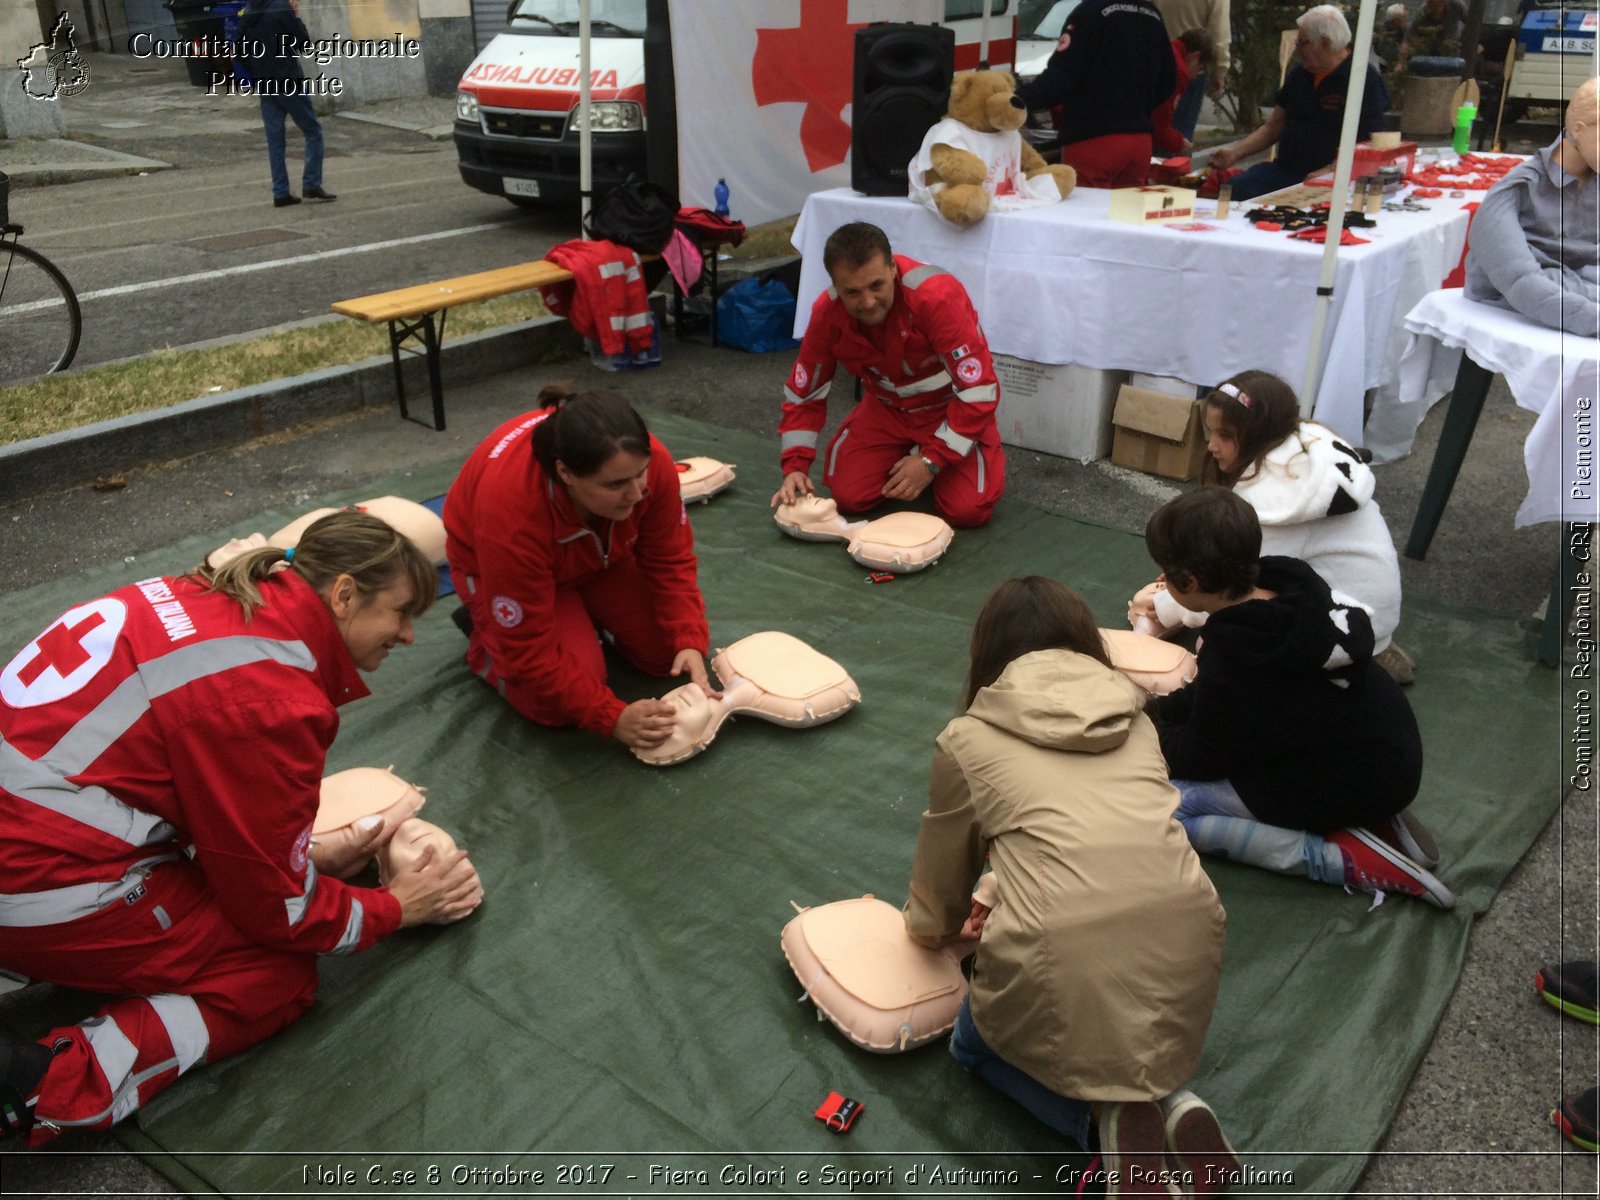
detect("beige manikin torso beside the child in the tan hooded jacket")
(779, 874), (997, 1054)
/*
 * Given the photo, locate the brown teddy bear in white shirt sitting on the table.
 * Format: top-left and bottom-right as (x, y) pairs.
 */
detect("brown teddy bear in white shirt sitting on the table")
(909, 70), (1078, 226)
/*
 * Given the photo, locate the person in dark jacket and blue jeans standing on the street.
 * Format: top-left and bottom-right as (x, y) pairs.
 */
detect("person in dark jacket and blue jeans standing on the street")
(238, 0), (338, 208)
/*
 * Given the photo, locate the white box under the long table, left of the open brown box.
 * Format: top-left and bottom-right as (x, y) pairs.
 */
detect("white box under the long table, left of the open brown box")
(994, 354), (1128, 462)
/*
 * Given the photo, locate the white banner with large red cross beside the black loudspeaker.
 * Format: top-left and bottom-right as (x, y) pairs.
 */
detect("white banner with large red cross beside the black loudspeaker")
(669, 0), (944, 226)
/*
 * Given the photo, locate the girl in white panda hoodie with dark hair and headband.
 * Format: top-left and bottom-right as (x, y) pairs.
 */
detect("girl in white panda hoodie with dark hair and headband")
(1128, 371), (1413, 683)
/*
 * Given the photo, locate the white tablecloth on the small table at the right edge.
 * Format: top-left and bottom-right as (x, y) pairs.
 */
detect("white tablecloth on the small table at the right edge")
(1400, 288), (1600, 526)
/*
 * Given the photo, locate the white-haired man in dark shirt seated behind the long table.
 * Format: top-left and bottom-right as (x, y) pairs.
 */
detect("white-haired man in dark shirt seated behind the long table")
(1211, 5), (1389, 200)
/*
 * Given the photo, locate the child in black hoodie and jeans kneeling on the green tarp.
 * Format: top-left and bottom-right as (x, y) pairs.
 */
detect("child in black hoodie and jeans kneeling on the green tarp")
(1144, 488), (1454, 909)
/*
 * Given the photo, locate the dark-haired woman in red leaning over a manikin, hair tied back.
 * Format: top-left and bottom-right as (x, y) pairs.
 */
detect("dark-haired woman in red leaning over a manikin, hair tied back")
(445, 386), (710, 747)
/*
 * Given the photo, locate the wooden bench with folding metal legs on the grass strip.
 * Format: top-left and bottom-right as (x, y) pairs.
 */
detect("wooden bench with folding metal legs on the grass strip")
(333, 259), (573, 429)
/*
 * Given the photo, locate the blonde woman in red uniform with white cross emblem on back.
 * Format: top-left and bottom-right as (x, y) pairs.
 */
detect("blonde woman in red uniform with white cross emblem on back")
(0, 512), (483, 1146)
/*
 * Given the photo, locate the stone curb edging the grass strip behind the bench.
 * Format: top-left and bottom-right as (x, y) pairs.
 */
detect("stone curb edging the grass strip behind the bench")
(0, 317), (582, 506)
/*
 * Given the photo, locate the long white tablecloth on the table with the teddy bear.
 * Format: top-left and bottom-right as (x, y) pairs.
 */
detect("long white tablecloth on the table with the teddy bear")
(794, 187), (1467, 440)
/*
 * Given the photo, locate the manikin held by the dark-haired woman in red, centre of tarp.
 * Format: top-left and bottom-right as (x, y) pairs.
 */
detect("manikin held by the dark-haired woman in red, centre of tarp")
(634, 630), (861, 766)
